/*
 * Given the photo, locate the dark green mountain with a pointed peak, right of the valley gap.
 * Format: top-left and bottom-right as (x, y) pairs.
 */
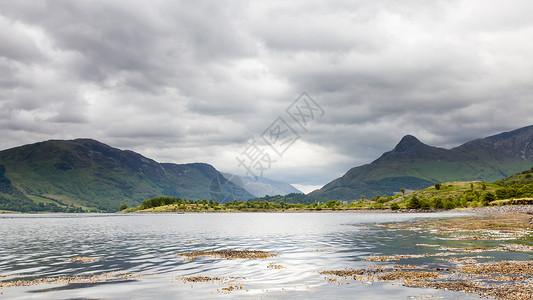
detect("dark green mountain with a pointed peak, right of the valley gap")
(309, 126), (533, 200)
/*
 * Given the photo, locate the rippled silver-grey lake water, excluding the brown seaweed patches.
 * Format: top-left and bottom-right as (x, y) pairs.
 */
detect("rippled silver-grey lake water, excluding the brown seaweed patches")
(0, 213), (516, 300)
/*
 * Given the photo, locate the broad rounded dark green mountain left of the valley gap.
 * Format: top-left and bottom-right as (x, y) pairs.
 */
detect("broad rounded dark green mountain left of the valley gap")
(0, 139), (253, 211)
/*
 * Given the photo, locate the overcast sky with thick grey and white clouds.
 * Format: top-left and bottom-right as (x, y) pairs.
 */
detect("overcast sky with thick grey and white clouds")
(0, 0), (533, 192)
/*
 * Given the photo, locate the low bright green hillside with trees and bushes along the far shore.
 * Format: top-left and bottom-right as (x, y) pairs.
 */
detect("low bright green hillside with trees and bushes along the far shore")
(122, 170), (533, 213)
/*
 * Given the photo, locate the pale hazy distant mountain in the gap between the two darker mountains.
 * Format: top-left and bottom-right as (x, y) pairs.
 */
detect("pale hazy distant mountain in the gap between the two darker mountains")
(222, 173), (303, 197)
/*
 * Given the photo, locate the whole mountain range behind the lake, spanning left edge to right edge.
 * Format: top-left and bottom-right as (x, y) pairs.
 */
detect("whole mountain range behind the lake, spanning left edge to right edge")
(0, 126), (533, 212)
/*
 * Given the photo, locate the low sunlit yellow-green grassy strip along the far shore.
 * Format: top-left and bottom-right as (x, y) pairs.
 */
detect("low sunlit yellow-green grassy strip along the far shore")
(123, 168), (533, 212)
